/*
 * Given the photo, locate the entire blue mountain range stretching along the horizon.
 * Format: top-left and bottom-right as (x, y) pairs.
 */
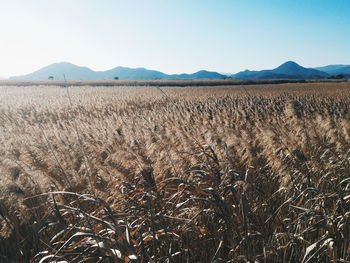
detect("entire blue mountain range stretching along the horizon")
(10, 61), (350, 80)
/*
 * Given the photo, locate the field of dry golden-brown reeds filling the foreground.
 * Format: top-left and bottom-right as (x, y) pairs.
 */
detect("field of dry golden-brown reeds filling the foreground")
(0, 82), (350, 263)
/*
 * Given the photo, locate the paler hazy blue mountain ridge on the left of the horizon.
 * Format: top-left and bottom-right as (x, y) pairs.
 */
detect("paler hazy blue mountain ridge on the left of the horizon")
(10, 62), (226, 80)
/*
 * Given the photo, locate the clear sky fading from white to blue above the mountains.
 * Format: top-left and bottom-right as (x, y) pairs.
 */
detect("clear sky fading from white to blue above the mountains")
(0, 0), (350, 77)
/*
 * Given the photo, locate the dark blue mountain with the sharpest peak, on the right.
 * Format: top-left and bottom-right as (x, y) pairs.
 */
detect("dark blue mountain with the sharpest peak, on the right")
(232, 61), (329, 79)
